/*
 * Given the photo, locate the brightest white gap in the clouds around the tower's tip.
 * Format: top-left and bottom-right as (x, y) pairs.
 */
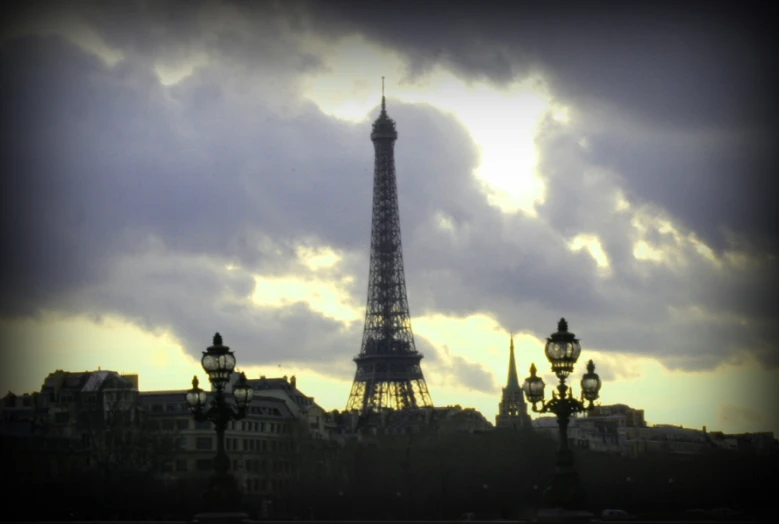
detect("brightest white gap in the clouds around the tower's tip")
(296, 37), (556, 216)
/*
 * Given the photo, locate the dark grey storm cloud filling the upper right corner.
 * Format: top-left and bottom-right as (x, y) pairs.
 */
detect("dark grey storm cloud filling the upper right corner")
(298, 0), (779, 251)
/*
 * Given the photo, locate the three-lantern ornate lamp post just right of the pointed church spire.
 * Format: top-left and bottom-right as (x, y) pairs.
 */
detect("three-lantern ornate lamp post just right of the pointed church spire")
(522, 318), (601, 509)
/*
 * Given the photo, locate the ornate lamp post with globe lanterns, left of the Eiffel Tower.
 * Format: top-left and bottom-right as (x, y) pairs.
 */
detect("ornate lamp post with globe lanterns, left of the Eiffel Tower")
(187, 333), (254, 511)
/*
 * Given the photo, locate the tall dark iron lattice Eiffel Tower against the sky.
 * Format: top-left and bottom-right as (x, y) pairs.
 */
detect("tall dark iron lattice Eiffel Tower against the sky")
(346, 85), (433, 413)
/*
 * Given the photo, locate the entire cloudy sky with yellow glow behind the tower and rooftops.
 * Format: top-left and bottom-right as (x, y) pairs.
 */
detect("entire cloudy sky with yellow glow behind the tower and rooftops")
(0, 0), (779, 434)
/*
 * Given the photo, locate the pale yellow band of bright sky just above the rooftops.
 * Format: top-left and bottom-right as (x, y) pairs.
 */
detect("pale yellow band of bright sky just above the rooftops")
(0, 313), (779, 434)
